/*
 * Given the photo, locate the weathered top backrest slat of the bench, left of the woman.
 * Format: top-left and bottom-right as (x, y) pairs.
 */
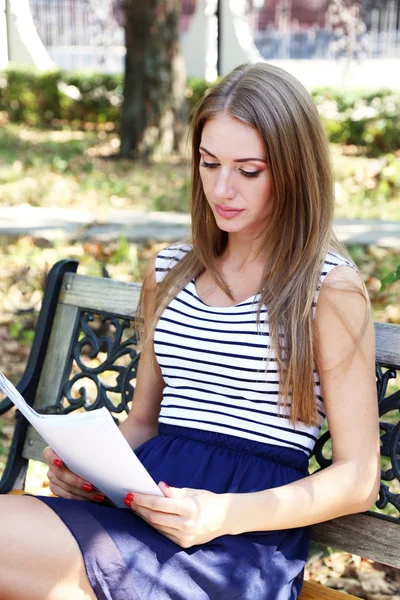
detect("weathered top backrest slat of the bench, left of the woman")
(60, 273), (142, 319)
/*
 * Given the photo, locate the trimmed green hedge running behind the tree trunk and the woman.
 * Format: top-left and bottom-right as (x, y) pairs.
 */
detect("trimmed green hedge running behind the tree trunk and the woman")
(0, 67), (400, 156)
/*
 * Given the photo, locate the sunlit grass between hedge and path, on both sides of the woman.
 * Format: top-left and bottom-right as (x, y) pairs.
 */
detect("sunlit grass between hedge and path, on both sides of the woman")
(0, 123), (400, 220)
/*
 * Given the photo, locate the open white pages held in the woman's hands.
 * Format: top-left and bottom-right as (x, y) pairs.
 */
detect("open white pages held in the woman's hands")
(0, 373), (163, 508)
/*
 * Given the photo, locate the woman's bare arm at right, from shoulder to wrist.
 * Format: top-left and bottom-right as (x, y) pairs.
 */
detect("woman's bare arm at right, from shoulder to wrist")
(223, 267), (380, 533)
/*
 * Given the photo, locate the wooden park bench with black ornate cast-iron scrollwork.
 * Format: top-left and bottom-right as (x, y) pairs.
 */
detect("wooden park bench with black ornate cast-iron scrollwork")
(0, 260), (400, 600)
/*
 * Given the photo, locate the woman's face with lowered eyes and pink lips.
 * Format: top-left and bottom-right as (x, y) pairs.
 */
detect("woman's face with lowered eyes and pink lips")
(200, 113), (272, 238)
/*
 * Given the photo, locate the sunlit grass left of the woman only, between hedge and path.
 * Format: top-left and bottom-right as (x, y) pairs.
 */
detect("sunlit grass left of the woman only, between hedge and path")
(0, 124), (188, 212)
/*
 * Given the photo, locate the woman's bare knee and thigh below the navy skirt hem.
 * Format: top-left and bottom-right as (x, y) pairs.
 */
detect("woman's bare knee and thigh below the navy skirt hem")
(0, 496), (96, 600)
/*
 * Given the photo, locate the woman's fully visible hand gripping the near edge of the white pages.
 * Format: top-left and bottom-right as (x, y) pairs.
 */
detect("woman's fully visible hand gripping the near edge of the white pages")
(125, 482), (230, 548)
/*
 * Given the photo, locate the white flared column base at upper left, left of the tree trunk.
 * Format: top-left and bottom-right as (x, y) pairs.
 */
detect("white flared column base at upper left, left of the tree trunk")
(6, 0), (54, 70)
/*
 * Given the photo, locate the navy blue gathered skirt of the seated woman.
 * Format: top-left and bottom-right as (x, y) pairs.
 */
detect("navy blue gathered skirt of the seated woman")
(36, 424), (311, 600)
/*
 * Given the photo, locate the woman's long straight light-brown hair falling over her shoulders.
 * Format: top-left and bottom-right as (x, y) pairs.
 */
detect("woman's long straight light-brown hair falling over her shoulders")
(139, 63), (364, 425)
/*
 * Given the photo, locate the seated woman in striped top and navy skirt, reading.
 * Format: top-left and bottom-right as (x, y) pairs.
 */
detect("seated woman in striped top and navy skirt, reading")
(0, 64), (379, 600)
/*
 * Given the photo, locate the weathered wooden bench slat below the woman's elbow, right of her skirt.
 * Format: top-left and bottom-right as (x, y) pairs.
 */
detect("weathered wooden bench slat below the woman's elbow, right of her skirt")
(312, 512), (400, 568)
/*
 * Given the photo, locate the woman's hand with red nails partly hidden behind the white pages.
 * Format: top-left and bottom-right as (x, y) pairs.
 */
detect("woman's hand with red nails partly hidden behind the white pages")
(43, 446), (104, 502)
